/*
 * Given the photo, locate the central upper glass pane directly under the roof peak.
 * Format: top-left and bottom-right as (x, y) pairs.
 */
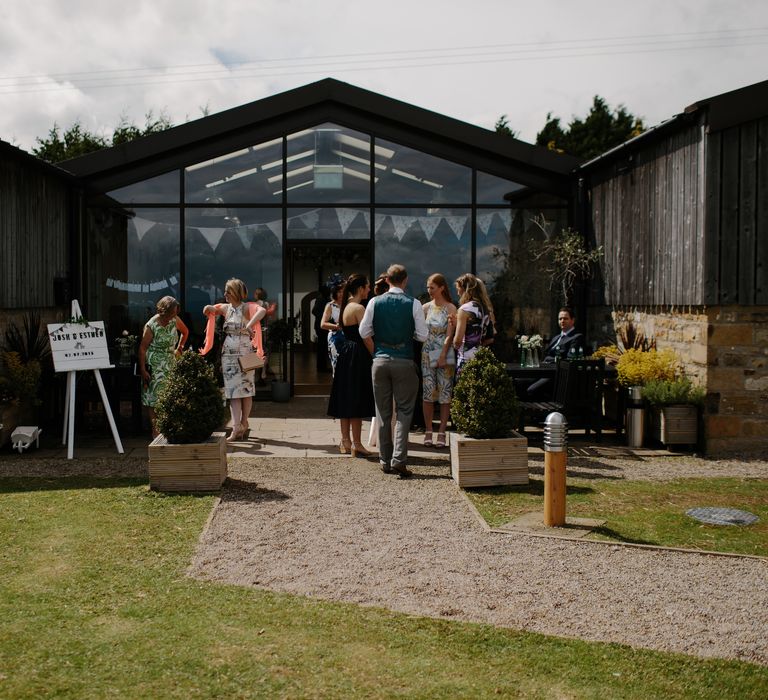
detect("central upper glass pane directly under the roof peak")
(288, 124), (371, 204)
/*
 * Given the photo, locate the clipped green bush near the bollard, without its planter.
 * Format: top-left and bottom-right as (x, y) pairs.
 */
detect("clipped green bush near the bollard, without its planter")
(451, 348), (518, 439)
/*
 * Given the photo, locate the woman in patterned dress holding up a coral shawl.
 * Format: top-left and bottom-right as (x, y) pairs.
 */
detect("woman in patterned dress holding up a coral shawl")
(203, 278), (267, 442)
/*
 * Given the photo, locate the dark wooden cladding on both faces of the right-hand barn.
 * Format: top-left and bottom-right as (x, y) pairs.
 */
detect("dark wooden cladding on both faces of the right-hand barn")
(589, 117), (768, 306)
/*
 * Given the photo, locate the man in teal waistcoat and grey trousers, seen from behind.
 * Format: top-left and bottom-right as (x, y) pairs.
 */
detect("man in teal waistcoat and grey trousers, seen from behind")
(360, 265), (428, 479)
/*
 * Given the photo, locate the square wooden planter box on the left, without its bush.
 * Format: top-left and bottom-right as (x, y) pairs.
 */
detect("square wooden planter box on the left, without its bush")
(149, 433), (227, 491)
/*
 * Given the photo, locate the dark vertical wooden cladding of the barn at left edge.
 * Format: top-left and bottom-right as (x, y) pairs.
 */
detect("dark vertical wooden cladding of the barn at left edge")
(0, 153), (70, 309)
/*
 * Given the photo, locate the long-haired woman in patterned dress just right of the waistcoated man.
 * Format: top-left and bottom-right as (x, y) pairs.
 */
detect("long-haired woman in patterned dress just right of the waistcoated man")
(421, 273), (456, 447)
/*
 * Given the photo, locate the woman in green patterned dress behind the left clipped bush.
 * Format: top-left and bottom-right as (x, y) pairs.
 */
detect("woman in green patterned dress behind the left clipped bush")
(139, 296), (189, 438)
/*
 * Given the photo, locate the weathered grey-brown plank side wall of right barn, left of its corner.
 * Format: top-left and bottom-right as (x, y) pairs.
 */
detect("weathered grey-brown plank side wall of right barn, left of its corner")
(591, 125), (705, 305)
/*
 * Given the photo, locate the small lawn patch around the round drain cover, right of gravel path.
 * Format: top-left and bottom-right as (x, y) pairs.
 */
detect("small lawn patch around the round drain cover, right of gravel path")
(467, 477), (768, 556)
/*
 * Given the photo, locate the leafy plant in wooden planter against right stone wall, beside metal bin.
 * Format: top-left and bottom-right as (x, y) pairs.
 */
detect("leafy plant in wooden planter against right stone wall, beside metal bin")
(643, 377), (706, 445)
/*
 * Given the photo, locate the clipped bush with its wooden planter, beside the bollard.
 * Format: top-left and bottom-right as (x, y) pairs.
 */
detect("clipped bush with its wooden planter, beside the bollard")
(451, 348), (528, 486)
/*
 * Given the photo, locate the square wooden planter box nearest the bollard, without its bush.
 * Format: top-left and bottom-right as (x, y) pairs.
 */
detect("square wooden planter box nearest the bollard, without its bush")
(451, 432), (528, 488)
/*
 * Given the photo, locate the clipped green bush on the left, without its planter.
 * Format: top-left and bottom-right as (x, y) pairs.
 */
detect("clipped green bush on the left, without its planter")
(155, 350), (226, 443)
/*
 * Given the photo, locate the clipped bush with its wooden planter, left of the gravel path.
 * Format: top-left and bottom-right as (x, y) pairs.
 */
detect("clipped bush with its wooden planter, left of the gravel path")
(149, 350), (227, 491)
